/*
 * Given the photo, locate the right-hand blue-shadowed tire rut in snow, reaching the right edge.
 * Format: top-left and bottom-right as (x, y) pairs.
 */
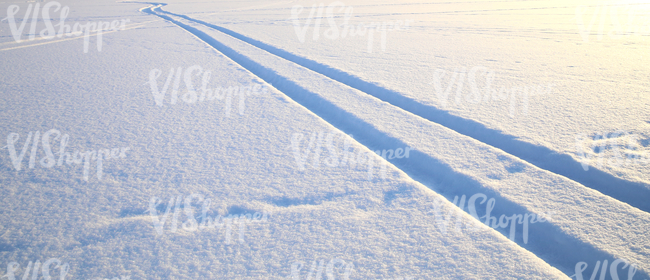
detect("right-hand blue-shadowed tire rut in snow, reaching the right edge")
(153, 4), (650, 213)
